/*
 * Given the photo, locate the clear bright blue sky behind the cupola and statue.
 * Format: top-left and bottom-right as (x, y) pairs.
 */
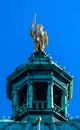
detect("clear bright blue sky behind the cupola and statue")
(0, 0), (80, 118)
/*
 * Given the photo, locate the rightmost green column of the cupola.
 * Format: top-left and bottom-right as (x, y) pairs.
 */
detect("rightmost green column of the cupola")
(61, 91), (68, 117)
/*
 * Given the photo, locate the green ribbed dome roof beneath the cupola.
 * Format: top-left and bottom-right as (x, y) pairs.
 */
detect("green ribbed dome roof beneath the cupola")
(0, 119), (80, 130)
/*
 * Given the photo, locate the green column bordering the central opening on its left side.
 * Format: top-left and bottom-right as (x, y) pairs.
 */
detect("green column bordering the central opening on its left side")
(27, 82), (33, 108)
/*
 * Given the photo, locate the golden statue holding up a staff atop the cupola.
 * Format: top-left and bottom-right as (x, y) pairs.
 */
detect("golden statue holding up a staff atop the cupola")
(30, 15), (48, 51)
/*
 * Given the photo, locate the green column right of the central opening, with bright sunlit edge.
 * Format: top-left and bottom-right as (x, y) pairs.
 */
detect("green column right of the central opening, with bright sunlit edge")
(47, 82), (53, 108)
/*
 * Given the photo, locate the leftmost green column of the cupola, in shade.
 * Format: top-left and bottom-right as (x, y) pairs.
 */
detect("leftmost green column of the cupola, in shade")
(12, 90), (19, 116)
